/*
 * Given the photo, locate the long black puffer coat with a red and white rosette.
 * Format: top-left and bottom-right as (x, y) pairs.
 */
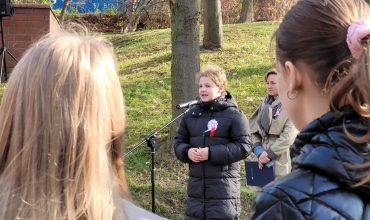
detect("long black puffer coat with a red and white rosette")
(174, 93), (251, 220)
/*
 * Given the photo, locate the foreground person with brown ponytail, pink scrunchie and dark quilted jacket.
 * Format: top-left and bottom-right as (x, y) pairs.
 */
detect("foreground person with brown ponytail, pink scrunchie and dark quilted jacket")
(252, 0), (370, 220)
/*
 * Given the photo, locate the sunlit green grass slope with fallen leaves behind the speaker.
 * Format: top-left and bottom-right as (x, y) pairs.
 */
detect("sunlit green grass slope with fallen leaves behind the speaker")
(0, 22), (278, 220)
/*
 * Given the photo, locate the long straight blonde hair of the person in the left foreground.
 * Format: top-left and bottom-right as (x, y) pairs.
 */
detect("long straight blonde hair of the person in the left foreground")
(0, 33), (128, 220)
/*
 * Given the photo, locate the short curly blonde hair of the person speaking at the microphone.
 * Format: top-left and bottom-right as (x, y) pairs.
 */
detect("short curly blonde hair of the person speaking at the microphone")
(195, 64), (227, 92)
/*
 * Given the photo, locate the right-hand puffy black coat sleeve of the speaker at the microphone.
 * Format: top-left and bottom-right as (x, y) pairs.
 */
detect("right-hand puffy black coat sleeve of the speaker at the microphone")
(209, 110), (251, 164)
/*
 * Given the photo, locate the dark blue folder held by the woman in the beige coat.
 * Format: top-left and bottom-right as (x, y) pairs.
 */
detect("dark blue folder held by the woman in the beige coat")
(244, 160), (275, 187)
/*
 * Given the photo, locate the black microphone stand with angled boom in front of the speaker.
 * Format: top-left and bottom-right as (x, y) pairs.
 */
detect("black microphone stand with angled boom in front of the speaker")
(124, 106), (190, 213)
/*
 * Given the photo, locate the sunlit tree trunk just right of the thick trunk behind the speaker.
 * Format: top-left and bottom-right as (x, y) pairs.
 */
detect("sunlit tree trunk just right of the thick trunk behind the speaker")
(203, 0), (224, 50)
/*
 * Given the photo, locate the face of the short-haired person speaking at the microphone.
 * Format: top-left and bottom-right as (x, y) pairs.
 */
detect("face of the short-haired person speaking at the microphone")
(199, 76), (223, 102)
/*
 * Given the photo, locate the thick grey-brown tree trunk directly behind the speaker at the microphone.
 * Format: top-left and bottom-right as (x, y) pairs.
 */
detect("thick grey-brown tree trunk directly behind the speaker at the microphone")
(168, 0), (201, 152)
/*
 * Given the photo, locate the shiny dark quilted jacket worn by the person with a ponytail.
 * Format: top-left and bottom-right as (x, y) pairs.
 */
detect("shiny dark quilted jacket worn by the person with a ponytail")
(252, 106), (370, 220)
